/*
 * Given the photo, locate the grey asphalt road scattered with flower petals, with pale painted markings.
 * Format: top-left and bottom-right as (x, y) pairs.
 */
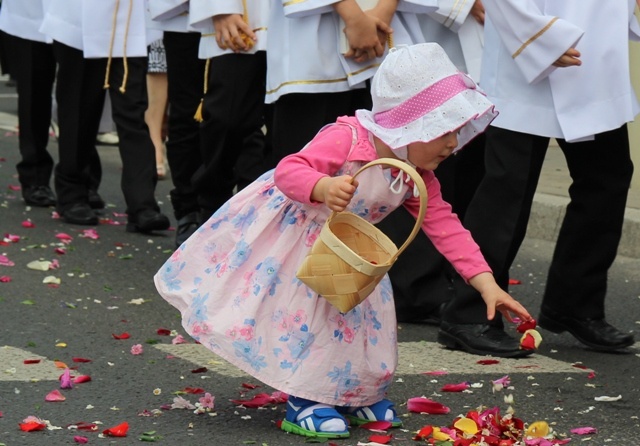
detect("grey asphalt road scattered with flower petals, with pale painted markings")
(0, 81), (640, 446)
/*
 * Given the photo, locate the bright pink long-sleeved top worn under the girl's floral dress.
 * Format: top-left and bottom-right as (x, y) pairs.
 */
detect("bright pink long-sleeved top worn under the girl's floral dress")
(275, 117), (491, 280)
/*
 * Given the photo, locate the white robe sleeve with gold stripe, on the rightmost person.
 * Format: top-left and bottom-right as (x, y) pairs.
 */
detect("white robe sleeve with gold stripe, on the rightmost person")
(483, 0), (584, 84)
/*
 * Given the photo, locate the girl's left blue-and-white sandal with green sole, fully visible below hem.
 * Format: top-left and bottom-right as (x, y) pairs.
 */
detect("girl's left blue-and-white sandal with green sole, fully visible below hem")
(280, 395), (349, 438)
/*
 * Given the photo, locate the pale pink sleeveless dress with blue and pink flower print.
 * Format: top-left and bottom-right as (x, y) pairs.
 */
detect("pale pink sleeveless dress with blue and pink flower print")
(155, 123), (413, 406)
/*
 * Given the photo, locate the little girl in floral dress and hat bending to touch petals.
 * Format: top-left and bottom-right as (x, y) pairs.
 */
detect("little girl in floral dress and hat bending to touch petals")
(155, 44), (531, 438)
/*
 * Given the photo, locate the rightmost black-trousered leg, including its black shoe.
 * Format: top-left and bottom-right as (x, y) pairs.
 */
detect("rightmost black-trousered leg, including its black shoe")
(539, 125), (633, 350)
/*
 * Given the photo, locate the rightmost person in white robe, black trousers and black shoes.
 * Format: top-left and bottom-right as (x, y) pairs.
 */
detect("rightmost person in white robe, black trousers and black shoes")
(438, 0), (640, 357)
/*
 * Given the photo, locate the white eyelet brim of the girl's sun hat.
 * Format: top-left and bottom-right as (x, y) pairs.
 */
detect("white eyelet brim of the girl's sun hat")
(356, 89), (498, 152)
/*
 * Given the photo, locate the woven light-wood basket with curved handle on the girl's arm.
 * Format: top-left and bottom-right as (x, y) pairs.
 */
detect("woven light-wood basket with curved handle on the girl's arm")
(296, 158), (427, 313)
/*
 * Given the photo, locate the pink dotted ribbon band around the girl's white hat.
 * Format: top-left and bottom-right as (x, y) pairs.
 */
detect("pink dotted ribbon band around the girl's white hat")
(374, 73), (476, 129)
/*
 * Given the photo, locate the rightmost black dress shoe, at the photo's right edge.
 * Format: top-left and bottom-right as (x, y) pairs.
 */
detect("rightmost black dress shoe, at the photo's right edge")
(538, 307), (635, 352)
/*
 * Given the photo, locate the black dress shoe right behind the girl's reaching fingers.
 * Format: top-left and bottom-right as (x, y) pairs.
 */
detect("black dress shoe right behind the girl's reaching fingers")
(438, 321), (533, 358)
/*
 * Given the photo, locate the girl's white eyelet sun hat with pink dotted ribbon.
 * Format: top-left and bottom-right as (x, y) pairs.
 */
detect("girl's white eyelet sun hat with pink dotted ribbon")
(356, 43), (498, 152)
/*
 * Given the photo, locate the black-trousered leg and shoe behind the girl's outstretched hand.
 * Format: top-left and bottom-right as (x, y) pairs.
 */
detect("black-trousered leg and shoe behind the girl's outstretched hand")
(438, 127), (549, 356)
